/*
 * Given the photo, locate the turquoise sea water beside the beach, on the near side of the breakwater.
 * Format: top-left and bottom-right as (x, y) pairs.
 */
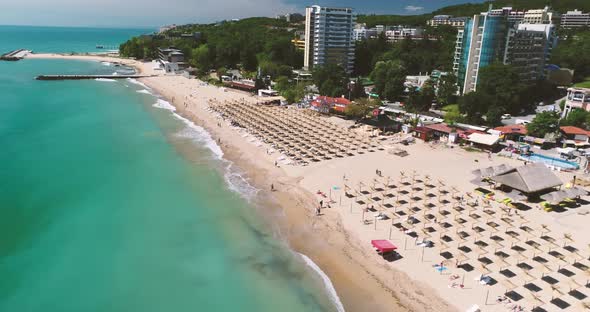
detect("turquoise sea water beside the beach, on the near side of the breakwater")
(0, 28), (336, 312)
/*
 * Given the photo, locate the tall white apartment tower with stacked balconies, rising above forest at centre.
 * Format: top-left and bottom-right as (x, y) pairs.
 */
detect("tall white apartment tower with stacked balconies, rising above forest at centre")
(303, 5), (356, 72)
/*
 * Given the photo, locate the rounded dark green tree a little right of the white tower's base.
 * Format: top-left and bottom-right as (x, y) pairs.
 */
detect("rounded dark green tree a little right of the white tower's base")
(371, 61), (407, 101)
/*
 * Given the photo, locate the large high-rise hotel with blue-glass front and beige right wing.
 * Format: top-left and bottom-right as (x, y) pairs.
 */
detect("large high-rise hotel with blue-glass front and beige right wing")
(453, 7), (557, 94)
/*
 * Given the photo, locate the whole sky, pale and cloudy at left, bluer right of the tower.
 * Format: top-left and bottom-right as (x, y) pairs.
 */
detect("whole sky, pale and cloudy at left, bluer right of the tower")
(0, 0), (482, 27)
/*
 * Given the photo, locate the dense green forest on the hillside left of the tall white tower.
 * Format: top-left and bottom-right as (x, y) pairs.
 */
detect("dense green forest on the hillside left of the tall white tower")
(120, 17), (303, 76)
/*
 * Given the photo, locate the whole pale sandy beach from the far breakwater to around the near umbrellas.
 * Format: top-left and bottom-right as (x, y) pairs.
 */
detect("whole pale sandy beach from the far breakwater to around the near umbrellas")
(28, 54), (590, 312)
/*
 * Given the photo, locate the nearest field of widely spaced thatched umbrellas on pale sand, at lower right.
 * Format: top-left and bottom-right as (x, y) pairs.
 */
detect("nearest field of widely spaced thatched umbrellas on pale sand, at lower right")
(344, 173), (590, 311)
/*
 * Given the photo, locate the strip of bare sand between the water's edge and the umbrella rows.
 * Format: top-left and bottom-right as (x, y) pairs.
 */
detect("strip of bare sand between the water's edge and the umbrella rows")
(27, 54), (456, 312)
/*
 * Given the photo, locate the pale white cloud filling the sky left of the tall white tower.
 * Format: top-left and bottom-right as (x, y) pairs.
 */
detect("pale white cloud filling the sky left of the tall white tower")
(0, 0), (297, 26)
